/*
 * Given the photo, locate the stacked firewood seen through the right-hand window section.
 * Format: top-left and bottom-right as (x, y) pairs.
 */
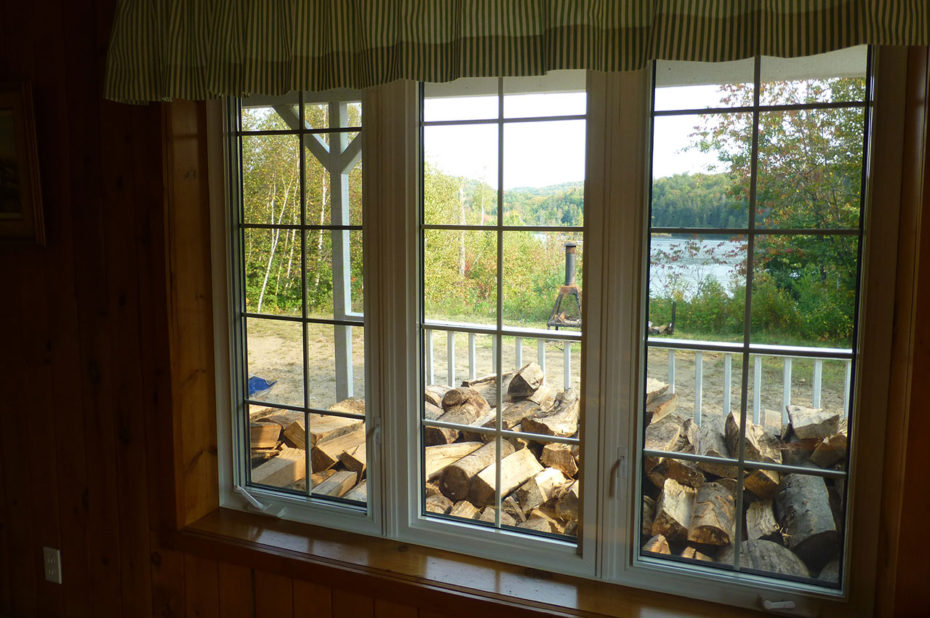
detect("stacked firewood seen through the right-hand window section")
(641, 380), (848, 583)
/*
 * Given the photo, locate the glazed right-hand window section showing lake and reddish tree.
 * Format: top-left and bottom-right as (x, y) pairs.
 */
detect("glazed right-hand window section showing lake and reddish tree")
(641, 48), (869, 587)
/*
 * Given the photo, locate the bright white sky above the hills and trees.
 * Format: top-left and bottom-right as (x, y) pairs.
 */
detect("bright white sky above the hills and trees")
(424, 86), (724, 190)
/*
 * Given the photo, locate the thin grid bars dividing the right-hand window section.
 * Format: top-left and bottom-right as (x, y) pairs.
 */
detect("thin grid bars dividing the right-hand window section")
(636, 54), (872, 588)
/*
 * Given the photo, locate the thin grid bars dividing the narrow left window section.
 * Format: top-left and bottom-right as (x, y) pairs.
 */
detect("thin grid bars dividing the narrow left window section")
(232, 92), (367, 507)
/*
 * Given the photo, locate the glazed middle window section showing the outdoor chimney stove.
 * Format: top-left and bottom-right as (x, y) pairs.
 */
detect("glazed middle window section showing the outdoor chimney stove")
(420, 71), (586, 538)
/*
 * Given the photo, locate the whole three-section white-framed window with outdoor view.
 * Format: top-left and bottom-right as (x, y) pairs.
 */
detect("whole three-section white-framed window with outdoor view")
(216, 48), (896, 611)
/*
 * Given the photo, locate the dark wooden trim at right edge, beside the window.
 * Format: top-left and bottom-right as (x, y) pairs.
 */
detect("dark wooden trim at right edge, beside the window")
(875, 47), (930, 616)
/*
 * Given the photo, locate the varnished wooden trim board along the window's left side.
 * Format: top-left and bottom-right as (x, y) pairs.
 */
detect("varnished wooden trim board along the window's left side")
(163, 101), (219, 528)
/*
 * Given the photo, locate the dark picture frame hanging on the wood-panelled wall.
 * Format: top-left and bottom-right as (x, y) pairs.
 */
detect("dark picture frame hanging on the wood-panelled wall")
(0, 82), (45, 245)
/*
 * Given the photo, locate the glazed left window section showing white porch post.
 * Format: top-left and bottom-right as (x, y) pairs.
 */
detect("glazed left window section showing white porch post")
(232, 92), (368, 508)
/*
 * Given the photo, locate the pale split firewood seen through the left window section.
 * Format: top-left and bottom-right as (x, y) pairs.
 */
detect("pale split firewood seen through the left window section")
(249, 399), (368, 502)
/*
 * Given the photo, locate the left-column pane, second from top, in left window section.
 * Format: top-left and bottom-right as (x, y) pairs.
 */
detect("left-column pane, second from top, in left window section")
(241, 135), (300, 225)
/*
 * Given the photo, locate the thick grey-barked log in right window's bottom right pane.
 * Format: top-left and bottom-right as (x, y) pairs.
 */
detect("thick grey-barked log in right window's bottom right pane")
(775, 474), (840, 571)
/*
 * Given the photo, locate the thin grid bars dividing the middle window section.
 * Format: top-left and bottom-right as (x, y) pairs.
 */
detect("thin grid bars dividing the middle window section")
(418, 78), (587, 542)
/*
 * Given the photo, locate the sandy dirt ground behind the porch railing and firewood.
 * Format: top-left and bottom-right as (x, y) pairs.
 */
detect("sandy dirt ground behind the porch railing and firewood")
(247, 319), (845, 427)
